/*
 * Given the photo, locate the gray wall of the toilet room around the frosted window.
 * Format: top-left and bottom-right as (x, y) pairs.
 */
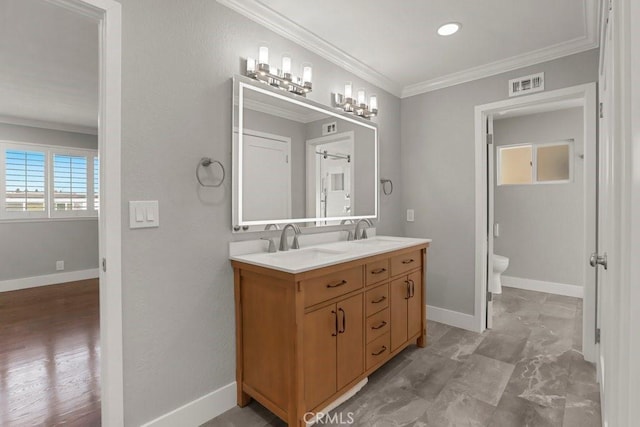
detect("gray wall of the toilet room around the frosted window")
(493, 108), (584, 286)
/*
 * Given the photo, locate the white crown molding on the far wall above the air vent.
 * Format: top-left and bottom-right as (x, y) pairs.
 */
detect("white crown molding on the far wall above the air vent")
(400, 37), (598, 98)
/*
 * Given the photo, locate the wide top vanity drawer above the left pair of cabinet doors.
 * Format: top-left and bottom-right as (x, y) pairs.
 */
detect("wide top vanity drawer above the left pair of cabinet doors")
(301, 267), (363, 307)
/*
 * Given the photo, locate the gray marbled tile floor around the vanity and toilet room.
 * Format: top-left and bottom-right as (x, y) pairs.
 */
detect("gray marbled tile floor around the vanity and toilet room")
(208, 288), (600, 427)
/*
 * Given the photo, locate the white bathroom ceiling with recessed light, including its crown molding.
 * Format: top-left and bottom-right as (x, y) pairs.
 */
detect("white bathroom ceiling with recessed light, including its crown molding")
(218, 0), (598, 96)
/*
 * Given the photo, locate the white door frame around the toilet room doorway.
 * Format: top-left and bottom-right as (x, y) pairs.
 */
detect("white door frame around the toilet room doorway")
(474, 83), (597, 362)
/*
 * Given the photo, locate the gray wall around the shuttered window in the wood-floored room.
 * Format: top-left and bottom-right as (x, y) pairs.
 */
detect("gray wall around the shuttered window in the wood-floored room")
(0, 123), (98, 281)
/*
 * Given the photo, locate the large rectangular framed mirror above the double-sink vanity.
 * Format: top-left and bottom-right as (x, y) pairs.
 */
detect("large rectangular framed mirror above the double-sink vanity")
(232, 76), (378, 232)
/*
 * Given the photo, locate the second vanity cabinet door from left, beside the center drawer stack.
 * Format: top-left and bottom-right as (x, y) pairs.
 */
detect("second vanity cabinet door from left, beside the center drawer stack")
(336, 294), (364, 390)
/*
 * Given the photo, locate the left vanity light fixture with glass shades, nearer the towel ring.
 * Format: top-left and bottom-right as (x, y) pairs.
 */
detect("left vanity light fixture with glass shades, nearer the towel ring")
(247, 46), (312, 96)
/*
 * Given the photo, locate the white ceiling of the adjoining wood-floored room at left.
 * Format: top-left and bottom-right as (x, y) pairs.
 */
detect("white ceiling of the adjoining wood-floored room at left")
(0, 0), (99, 133)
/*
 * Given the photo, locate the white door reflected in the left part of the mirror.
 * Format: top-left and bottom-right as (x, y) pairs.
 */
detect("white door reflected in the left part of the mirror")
(242, 130), (291, 221)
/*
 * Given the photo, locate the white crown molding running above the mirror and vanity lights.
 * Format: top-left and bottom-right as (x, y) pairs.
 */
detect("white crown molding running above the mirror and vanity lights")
(217, 0), (402, 97)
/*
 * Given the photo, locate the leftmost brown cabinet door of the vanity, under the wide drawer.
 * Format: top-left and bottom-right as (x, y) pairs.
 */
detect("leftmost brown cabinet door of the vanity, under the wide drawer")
(304, 304), (338, 409)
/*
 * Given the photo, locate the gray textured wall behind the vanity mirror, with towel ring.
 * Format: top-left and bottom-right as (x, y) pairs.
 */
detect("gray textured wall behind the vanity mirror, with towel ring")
(121, 0), (402, 426)
